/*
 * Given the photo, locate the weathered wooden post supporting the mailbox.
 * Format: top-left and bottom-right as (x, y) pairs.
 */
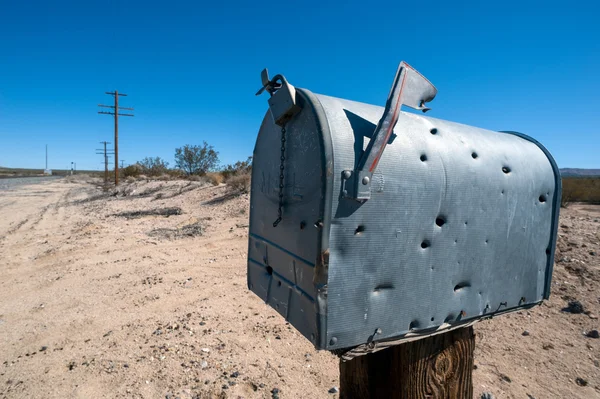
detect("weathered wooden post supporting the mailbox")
(340, 326), (475, 399)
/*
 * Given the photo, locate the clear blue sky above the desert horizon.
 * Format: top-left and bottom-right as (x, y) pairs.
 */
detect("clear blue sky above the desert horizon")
(0, 0), (600, 169)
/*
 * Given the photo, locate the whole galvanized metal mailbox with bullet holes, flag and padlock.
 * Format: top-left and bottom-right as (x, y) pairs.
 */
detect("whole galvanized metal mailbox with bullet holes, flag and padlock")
(248, 62), (561, 353)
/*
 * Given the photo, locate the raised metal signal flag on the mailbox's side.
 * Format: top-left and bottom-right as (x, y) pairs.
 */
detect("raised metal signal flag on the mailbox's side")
(342, 61), (437, 202)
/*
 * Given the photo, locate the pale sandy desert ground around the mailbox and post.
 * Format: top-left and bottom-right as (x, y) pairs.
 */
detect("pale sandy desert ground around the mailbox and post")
(0, 179), (600, 399)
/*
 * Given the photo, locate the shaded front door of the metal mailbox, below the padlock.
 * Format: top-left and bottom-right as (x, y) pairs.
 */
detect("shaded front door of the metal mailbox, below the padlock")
(247, 89), (333, 348)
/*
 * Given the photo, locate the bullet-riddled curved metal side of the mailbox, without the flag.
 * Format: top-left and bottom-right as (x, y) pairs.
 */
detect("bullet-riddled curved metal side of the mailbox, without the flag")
(317, 96), (560, 349)
